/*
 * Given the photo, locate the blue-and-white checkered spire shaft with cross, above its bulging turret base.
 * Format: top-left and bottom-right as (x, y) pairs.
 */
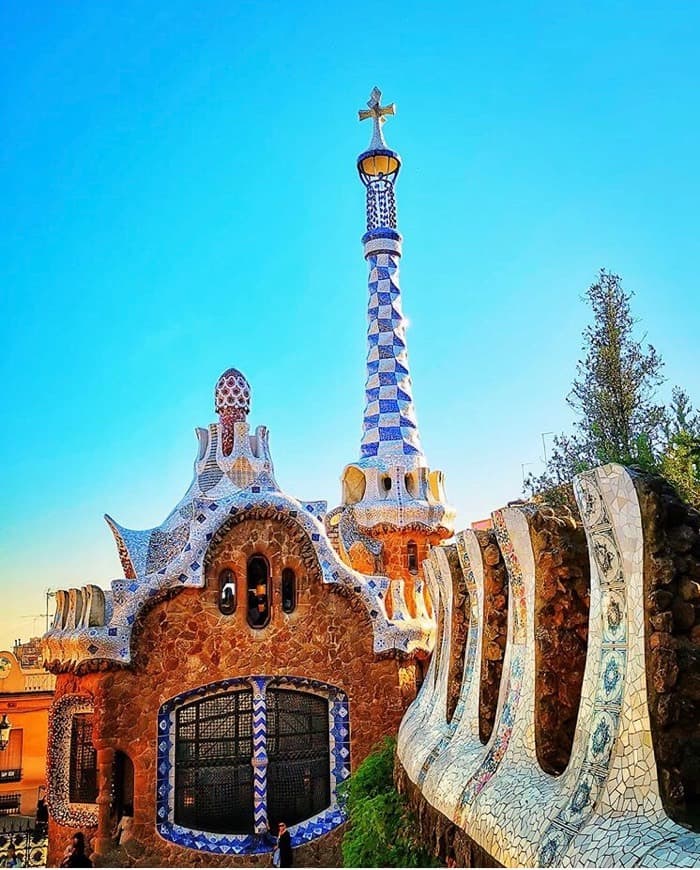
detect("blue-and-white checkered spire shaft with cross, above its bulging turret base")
(357, 88), (426, 468)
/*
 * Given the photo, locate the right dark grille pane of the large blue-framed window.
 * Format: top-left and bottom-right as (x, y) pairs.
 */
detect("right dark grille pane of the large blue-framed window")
(267, 687), (331, 830)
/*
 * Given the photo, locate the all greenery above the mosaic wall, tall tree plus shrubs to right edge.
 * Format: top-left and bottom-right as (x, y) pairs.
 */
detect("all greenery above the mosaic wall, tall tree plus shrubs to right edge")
(525, 269), (700, 507)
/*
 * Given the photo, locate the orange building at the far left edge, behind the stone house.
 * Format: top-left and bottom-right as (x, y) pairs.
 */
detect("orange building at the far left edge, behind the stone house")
(0, 638), (56, 816)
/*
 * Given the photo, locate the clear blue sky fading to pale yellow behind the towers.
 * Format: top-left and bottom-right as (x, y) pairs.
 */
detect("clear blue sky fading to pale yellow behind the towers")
(0, 0), (700, 647)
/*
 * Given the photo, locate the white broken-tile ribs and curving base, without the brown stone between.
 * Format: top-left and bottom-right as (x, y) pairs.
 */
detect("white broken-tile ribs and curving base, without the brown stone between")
(398, 465), (700, 867)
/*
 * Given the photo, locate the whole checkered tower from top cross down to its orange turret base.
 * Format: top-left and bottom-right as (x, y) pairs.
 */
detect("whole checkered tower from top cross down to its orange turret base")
(328, 88), (454, 610)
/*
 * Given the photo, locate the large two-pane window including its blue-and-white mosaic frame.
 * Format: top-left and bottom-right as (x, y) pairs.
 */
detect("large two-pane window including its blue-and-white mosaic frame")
(157, 676), (351, 855)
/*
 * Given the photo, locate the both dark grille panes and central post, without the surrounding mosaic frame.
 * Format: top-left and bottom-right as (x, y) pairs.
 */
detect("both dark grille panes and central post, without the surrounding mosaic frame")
(172, 678), (334, 835)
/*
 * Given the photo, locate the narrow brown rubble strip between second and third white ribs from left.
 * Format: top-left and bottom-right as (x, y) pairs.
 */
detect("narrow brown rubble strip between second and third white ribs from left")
(475, 529), (508, 743)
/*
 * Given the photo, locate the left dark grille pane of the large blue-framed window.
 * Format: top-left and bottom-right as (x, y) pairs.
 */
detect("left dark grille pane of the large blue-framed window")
(175, 691), (253, 834)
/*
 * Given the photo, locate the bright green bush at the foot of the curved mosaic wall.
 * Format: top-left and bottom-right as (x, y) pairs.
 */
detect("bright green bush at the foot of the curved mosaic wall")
(340, 737), (440, 867)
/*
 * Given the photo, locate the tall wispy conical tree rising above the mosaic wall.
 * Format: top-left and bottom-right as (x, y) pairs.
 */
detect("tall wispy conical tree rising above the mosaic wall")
(525, 269), (666, 495)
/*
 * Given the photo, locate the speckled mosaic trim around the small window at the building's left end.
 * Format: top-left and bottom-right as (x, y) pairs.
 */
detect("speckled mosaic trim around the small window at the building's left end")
(46, 695), (97, 828)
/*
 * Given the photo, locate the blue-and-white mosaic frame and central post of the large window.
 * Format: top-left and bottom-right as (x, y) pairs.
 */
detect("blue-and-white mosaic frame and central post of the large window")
(156, 675), (350, 855)
